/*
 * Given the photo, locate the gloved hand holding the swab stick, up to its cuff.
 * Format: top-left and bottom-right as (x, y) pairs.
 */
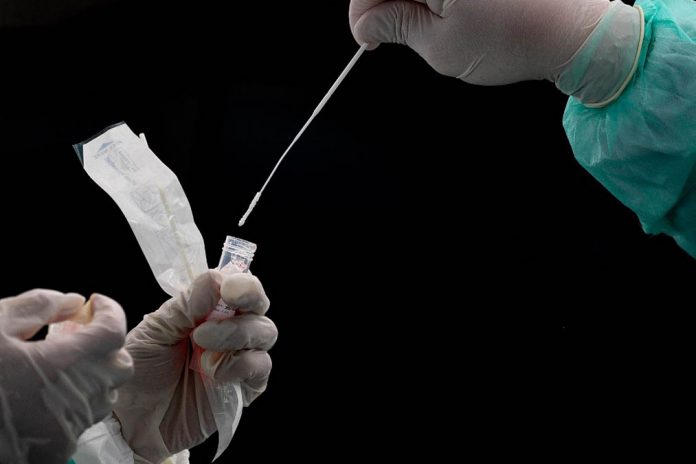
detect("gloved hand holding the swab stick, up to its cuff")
(349, 0), (610, 85)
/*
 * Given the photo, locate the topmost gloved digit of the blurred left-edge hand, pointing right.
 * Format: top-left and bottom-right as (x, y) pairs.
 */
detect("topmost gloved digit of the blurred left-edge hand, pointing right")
(0, 289), (85, 340)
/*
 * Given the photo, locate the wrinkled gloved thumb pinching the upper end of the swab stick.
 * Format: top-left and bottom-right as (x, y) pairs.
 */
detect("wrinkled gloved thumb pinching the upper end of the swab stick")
(353, 0), (441, 48)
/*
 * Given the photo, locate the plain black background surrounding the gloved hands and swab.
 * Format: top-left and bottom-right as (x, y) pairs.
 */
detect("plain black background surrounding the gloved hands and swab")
(0, 1), (696, 462)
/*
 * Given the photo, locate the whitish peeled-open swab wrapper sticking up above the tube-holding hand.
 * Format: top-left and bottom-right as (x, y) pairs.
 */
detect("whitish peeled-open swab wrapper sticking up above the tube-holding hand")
(75, 123), (208, 296)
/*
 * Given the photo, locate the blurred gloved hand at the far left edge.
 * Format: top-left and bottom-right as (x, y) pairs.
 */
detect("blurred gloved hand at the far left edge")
(0, 290), (133, 464)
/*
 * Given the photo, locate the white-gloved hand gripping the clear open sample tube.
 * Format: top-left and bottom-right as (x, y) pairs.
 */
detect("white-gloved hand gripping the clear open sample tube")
(114, 271), (278, 463)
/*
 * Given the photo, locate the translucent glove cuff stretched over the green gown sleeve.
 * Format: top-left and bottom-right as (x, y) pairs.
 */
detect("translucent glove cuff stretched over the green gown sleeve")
(556, 1), (644, 107)
